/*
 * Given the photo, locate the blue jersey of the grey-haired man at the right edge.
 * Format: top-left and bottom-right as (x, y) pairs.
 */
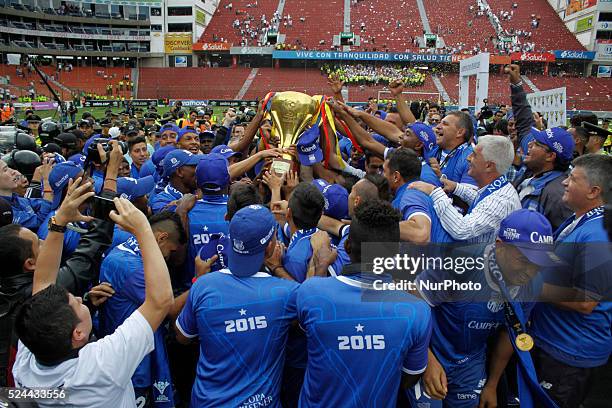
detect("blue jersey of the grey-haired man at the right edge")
(531, 207), (612, 367)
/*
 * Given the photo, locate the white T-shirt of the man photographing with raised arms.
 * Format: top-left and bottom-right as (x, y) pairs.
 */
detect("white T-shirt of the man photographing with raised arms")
(13, 310), (154, 408)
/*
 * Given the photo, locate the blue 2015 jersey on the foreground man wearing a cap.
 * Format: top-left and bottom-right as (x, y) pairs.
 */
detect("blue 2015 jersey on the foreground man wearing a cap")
(176, 269), (298, 407)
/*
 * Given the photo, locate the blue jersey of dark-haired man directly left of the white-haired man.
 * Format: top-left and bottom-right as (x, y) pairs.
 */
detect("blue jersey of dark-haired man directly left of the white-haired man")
(392, 183), (454, 243)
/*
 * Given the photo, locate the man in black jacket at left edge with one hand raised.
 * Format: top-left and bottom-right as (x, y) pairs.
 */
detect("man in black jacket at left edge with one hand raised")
(0, 171), (114, 386)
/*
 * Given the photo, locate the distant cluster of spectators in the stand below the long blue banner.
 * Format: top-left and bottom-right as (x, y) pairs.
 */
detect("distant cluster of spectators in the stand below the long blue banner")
(321, 64), (426, 86)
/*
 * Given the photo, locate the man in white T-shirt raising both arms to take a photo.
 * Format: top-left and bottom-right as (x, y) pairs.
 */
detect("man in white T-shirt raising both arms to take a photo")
(13, 196), (173, 407)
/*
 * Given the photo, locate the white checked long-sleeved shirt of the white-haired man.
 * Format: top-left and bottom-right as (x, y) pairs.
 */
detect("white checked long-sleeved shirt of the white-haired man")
(430, 183), (521, 243)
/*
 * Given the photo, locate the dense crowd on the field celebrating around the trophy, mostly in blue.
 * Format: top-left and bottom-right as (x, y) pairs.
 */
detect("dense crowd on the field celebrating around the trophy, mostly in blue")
(0, 65), (612, 408)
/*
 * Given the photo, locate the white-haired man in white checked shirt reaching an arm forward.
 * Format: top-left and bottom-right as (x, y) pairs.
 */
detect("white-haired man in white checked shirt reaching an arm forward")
(409, 135), (521, 243)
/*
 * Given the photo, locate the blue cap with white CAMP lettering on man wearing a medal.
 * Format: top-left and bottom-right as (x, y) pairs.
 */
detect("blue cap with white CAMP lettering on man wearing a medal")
(497, 208), (562, 266)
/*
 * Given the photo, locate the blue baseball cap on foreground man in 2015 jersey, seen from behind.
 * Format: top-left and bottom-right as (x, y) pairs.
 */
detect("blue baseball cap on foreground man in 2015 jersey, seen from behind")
(228, 204), (276, 277)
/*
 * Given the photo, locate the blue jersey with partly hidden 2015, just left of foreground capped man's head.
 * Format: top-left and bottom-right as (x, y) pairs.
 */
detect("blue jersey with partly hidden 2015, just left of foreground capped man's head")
(184, 195), (229, 285)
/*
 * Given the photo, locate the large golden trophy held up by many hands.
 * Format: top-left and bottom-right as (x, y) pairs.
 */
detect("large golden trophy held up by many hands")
(270, 91), (320, 175)
